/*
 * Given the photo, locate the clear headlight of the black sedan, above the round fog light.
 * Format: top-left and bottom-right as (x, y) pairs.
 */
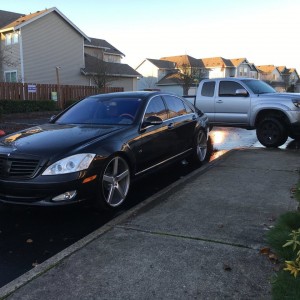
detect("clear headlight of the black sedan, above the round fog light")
(42, 153), (96, 175)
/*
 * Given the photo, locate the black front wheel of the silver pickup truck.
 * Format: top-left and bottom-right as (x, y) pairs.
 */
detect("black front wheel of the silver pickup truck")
(256, 117), (288, 148)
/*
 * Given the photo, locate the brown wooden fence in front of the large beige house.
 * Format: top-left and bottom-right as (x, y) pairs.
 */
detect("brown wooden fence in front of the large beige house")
(0, 82), (124, 102)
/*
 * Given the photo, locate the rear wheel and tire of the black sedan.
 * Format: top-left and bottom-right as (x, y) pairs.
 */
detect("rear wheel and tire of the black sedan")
(190, 130), (212, 165)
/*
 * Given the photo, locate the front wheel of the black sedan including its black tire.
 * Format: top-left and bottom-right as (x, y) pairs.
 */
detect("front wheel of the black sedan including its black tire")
(96, 155), (130, 211)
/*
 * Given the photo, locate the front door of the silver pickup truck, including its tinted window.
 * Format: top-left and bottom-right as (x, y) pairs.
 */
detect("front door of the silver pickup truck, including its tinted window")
(214, 80), (251, 125)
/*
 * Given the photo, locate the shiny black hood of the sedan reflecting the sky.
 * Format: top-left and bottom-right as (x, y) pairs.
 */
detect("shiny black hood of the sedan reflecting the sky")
(0, 124), (124, 157)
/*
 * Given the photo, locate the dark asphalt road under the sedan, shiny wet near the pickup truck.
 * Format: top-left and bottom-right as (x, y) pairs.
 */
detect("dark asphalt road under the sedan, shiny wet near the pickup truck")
(0, 128), (300, 287)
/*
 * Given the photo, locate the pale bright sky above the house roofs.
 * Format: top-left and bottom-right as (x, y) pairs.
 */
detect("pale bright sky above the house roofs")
(0, 0), (300, 74)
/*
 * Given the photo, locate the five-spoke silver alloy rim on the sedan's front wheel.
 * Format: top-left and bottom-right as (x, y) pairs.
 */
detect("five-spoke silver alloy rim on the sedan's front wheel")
(102, 156), (130, 207)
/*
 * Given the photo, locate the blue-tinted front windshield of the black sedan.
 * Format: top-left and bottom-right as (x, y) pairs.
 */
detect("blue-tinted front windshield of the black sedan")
(55, 96), (141, 125)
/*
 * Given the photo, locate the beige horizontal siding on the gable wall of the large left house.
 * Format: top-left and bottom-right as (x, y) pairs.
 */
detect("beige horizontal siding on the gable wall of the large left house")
(22, 12), (84, 84)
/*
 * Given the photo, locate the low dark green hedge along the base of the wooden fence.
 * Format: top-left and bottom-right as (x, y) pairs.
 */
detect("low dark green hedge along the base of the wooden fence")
(0, 100), (57, 116)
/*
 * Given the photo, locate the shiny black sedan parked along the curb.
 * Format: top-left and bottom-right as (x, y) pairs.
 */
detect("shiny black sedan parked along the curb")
(0, 92), (208, 210)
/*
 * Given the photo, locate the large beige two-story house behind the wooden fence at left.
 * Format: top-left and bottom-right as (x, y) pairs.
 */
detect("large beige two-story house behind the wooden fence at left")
(0, 7), (140, 90)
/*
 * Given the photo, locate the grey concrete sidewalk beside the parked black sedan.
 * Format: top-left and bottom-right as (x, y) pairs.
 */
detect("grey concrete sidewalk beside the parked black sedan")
(0, 149), (300, 300)
